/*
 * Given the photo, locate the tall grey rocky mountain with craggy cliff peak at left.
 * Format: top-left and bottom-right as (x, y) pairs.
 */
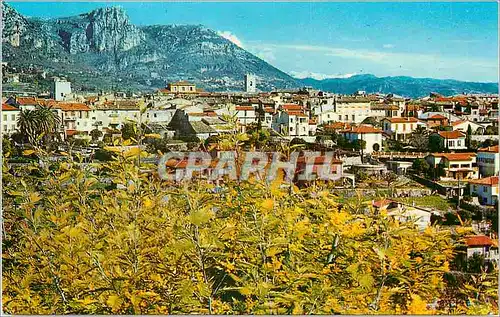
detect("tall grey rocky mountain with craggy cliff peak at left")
(4, 6), (297, 90)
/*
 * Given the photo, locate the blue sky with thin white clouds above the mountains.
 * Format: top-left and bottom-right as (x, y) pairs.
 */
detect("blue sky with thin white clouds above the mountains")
(11, 1), (498, 82)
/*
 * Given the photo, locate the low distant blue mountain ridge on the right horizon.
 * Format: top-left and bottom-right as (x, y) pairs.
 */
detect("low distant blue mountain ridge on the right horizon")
(300, 74), (498, 98)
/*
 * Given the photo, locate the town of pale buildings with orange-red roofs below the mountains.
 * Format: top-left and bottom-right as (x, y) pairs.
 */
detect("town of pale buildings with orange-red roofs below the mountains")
(2, 74), (500, 260)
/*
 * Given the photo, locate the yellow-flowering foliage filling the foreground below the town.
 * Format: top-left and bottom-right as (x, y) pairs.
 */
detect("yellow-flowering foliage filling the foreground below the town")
(2, 153), (498, 314)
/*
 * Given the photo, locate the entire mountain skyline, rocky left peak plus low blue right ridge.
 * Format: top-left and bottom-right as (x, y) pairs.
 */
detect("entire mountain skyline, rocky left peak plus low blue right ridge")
(2, 3), (498, 97)
